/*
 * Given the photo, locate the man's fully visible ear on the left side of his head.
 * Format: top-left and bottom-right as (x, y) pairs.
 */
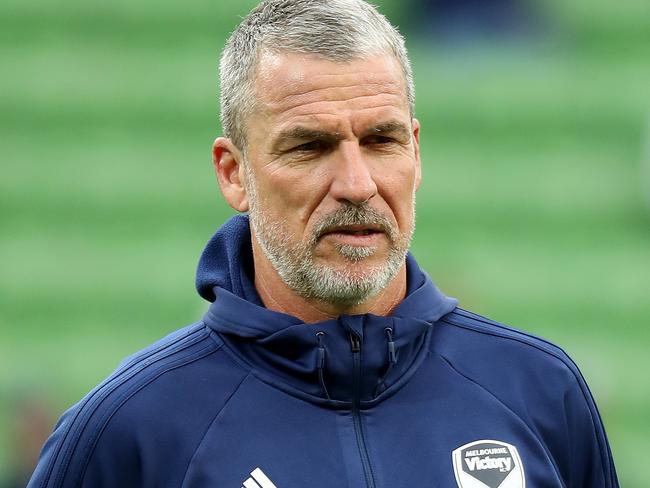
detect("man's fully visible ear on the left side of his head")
(212, 137), (248, 212)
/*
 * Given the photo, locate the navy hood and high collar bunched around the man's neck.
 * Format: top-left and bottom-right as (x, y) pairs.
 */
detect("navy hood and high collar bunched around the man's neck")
(196, 215), (458, 407)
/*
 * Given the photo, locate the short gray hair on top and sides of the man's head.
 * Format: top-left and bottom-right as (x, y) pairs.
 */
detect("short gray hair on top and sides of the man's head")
(219, 0), (415, 152)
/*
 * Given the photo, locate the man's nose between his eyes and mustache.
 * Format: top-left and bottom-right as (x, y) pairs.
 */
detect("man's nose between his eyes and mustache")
(330, 142), (377, 204)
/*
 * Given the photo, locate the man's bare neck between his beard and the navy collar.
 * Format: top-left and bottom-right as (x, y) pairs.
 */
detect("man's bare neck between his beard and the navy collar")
(253, 238), (406, 323)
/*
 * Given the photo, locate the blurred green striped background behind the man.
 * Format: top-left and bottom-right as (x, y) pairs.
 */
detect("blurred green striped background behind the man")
(0, 0), (650, 488)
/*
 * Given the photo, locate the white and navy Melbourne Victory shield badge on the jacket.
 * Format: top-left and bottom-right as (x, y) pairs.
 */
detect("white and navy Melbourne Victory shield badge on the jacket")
(451, 440), (526, 488)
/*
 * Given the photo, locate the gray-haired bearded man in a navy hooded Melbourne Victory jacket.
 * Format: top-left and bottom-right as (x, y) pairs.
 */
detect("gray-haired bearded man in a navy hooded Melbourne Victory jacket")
(29, 0), (618, 488)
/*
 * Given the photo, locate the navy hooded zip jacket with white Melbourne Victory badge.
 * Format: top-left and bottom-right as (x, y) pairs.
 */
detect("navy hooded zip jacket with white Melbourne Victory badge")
(28, 216), (618, 488)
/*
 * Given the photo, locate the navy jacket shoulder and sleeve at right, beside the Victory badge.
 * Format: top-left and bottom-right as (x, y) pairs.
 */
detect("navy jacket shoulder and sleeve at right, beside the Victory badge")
(431, 309), (617, 487)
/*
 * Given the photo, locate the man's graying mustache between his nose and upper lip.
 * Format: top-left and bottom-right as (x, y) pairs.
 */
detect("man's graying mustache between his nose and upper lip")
(313, 203), (398, 240)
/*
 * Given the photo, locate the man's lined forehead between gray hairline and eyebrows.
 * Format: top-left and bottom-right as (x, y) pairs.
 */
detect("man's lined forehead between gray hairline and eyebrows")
(255, 52), (409, 134)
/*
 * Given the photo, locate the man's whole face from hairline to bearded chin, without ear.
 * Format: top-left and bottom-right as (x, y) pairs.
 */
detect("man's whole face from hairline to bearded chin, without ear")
(244, 54), (420, 304)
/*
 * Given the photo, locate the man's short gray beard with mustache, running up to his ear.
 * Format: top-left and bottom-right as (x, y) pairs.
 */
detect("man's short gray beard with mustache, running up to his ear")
(247, 167), (415, 306)
